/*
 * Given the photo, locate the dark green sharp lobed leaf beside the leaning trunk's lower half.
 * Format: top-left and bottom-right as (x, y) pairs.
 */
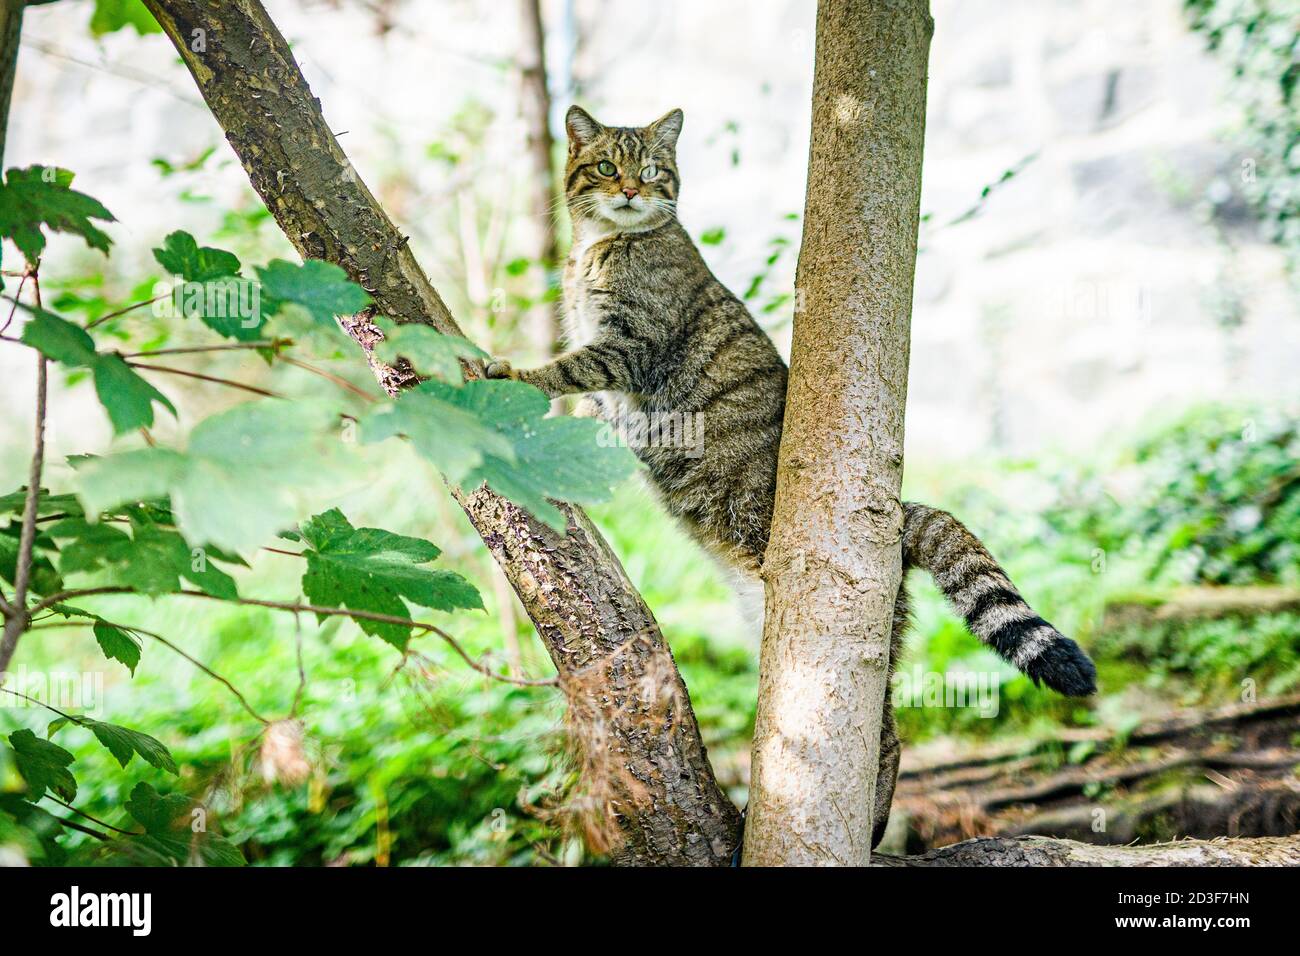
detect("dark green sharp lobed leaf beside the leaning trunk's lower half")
(302, 509), (484, 648)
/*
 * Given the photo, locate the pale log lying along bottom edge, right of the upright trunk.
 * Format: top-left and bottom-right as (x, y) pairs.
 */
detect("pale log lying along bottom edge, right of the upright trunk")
(872, 835), (1300, 866)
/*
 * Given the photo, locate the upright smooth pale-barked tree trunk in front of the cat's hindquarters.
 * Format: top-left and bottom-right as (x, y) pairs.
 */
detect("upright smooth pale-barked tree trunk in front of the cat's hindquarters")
(745, 0), (932, 865)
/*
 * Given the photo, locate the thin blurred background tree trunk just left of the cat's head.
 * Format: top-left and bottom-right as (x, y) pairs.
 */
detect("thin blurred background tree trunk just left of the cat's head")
(519, 0), (559, 362)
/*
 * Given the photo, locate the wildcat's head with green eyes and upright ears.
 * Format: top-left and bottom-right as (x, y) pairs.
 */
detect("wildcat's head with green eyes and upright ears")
(564, 107), (683, 229)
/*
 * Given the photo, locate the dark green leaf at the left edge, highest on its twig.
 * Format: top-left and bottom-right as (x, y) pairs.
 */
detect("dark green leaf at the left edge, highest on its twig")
(0, 166), (113, 264)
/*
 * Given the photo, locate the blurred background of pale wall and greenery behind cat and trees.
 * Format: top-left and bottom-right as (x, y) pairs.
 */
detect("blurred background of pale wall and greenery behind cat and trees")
(0, 0), (1300, 865)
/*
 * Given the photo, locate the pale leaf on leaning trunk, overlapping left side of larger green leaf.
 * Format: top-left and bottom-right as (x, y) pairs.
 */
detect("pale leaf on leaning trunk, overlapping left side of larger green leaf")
(361, 381), (515, 484)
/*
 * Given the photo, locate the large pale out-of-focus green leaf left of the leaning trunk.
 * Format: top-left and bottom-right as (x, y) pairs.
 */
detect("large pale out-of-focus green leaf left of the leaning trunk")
(77, 401), (343, 553)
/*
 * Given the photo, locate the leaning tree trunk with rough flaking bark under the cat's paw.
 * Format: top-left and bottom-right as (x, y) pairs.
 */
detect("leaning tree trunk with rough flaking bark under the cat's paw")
(144, 0), (740, 865)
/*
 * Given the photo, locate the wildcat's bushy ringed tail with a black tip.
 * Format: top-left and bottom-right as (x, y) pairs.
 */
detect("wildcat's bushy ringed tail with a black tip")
(902, 502), (1097, 697)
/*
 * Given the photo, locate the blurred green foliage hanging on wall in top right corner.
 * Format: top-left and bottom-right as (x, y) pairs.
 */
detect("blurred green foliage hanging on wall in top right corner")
(1184, 0), (1300, 268)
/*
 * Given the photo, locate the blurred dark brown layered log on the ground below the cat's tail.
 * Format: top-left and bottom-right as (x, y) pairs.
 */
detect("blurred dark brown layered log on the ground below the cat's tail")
(884, 697), (1300, 852)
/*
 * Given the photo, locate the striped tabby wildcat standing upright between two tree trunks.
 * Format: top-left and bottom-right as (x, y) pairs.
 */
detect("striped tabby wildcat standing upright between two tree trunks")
(488, 107), (1096, 844)
